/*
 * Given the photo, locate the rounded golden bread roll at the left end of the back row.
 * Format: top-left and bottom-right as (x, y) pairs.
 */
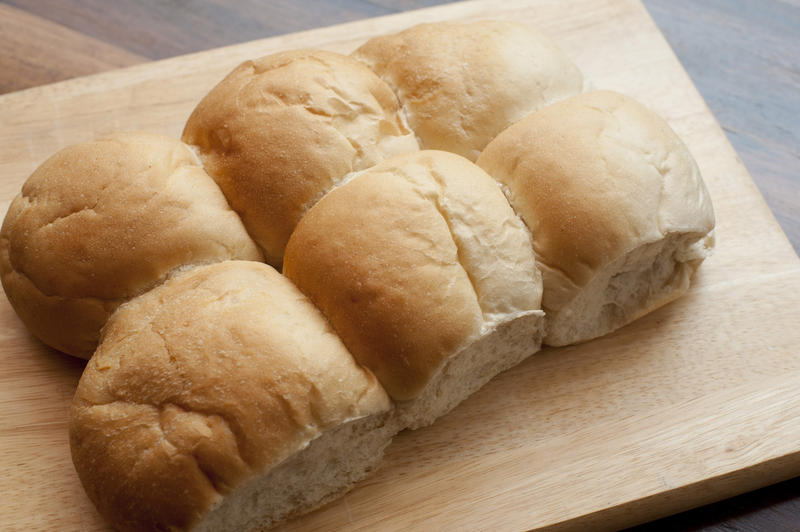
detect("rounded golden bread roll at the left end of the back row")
(0, 133), (262, 358)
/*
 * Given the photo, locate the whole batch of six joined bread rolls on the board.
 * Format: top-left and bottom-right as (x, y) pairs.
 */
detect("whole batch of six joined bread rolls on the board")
(0, 21), (714, 531)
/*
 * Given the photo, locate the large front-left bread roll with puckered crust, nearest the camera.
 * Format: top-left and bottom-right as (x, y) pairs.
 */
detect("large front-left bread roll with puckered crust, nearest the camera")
(70, 261), (393, 531)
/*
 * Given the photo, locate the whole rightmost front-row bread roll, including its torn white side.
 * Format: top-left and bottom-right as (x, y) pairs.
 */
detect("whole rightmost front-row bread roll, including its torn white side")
(478, 91), (714, 345)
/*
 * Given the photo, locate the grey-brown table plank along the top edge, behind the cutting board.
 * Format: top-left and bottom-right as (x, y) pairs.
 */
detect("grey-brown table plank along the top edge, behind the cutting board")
(4, 0), (451, 59)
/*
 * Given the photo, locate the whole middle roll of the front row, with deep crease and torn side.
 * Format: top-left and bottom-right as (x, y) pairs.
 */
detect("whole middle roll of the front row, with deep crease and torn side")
(284, 151), (543, 428)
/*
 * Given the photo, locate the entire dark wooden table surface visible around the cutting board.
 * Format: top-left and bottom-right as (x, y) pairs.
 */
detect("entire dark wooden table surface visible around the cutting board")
(0, 0), (800, 531)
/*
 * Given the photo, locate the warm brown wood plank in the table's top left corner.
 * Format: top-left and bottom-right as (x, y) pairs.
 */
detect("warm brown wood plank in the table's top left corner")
(0, 4), (147, 93)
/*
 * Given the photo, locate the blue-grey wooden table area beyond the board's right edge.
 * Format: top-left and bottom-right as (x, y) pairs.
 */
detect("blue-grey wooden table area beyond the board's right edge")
(644, 0), (800, 251)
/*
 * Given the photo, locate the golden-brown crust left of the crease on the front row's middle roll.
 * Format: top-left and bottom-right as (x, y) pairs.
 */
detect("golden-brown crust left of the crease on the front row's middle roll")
(284, 154), (481, 400)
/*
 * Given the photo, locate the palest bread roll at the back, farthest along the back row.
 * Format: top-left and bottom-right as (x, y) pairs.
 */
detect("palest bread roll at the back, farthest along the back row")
(352, 20), (583, 161)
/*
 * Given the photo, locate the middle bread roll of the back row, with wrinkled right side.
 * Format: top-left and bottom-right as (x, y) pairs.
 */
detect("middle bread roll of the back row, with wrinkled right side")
(183, 50), (418, 267)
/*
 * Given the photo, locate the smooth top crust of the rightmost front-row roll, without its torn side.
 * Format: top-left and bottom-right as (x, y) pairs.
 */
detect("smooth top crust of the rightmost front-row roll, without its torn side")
(477, 91), (714, 312)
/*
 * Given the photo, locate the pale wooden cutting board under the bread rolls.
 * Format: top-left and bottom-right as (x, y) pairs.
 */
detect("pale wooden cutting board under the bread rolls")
(0, 0), (800, 531)
